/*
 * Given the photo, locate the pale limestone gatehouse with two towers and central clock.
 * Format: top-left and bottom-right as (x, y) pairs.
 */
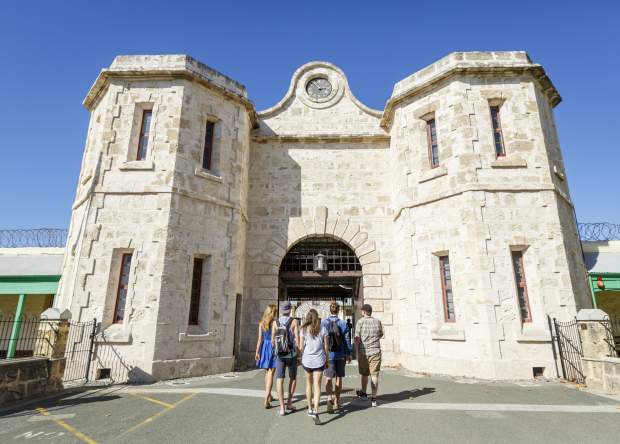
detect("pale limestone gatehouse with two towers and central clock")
(56, 52), (591, 379)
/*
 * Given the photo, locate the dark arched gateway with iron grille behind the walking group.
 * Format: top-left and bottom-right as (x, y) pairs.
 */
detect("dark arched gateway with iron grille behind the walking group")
(278, 236), (362, 324)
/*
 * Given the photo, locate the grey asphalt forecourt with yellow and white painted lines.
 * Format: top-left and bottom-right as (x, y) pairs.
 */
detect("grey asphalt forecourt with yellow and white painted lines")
(0, 367), (620, 444)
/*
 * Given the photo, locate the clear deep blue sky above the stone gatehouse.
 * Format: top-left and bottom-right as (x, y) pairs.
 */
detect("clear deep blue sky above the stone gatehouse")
(0, 0), (620, 228)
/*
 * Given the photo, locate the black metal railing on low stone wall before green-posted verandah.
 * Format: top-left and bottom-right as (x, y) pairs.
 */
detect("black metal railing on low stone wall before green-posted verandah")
(0, 317), (55, 360)
